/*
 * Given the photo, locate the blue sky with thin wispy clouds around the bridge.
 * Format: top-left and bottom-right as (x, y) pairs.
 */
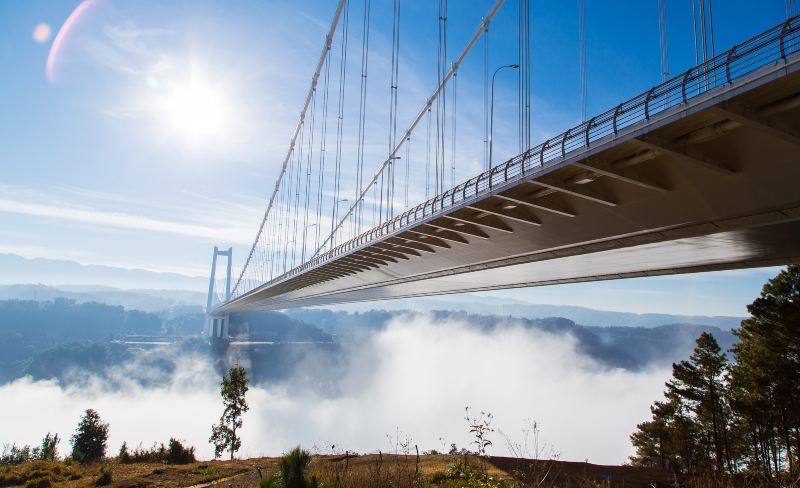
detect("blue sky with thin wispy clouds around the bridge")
(0, 0), (785, 314)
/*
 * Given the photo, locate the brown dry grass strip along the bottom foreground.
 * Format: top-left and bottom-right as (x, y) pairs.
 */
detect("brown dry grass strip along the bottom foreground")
(0, 454), (674, 488)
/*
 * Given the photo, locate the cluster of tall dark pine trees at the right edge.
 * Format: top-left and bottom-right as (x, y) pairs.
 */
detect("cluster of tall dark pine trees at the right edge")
(631, 265), (800, 482)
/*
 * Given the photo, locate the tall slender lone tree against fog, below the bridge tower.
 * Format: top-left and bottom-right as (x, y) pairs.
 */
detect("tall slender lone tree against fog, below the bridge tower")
(208, 366), (250, 459)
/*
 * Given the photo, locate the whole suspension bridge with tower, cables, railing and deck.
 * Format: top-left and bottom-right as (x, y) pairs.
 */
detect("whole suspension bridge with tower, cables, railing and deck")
(207, 0), (800, 336)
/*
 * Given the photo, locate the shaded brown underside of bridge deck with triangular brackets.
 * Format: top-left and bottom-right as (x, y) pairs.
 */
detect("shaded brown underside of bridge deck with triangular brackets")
(221, 58), (800, 310)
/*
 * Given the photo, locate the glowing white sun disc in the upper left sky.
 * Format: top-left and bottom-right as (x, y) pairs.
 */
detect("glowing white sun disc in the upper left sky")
(160, 77), (233, 146)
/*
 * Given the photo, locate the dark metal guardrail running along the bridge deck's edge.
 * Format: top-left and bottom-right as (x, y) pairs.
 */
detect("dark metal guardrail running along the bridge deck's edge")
(231, 16), (800, 301)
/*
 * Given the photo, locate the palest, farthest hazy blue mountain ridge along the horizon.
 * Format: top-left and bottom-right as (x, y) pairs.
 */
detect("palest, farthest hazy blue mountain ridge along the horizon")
(0, 254), (744, 329)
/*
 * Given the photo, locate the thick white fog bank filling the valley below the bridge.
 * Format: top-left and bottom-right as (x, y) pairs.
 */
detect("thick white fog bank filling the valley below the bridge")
(0, 315), (670, 464)
